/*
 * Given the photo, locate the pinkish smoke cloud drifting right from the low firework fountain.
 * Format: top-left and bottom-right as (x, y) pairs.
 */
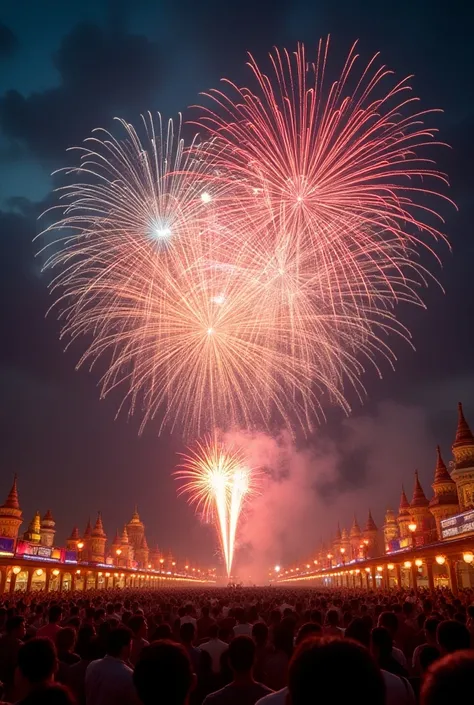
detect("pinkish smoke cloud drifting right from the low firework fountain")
(226, 402), (436, 583)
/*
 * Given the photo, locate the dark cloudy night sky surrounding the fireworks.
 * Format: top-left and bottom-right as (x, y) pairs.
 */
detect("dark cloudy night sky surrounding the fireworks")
(0, 0), (474, 572)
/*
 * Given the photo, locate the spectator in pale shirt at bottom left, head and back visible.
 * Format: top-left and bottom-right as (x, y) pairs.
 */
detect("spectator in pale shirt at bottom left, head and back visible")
(86, 627), (137, 705)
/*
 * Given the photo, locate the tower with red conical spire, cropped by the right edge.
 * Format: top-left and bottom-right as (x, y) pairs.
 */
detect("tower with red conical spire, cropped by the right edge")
(451, 402), (474, 512)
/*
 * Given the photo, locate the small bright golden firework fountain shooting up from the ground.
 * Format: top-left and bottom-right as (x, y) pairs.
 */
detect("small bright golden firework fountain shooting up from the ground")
(175, 434), (257, 576)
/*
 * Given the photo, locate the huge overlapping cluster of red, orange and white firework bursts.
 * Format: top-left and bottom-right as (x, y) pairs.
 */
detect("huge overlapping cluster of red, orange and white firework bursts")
(39, 42), (454, 434)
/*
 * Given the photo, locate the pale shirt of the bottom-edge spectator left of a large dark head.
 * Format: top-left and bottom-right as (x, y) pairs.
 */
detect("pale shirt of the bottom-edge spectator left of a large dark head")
(86, 656), (139, 705)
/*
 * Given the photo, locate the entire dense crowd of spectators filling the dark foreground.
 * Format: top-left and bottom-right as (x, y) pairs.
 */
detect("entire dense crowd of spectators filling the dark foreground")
(0, 587), (474, 705)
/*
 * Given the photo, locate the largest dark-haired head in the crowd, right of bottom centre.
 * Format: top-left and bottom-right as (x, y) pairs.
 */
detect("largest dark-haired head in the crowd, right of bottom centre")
(288, 637), (385, 705)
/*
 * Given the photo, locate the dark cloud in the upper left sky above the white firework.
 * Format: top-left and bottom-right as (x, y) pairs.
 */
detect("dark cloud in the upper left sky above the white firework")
(0, 24), (161, 163)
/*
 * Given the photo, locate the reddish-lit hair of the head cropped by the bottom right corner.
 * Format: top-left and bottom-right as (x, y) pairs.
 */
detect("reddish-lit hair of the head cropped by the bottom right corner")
(421, 651), (474, 705)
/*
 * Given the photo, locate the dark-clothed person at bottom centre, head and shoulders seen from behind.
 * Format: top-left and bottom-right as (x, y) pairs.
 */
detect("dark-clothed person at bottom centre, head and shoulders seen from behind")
(204, 636), (272, 705)
